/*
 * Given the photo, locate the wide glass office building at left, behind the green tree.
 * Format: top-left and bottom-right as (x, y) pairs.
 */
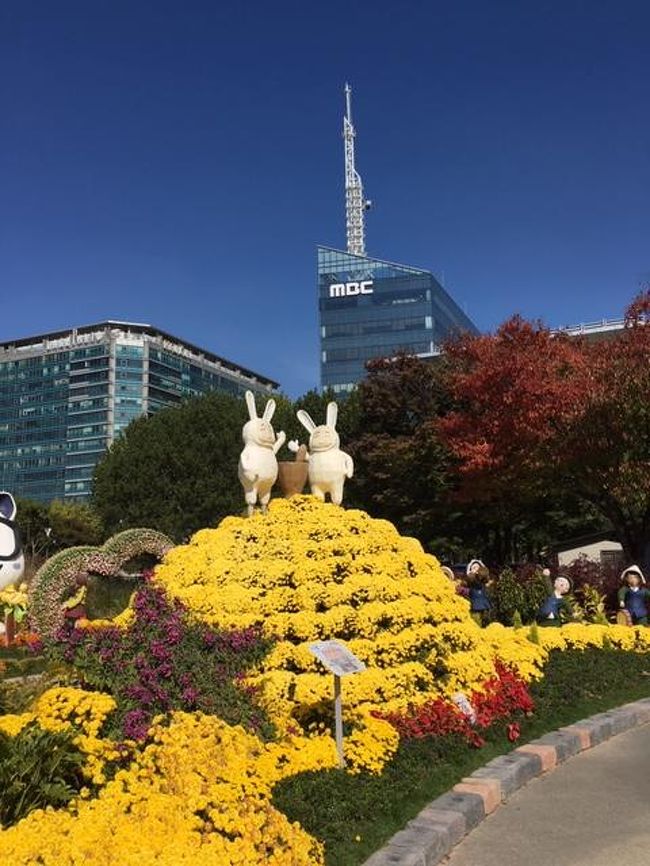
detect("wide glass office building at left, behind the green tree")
(0, 321), (278, 502)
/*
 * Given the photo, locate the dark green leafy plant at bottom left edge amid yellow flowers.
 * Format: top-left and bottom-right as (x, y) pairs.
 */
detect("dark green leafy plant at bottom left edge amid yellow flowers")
(0, 723), (84, 828)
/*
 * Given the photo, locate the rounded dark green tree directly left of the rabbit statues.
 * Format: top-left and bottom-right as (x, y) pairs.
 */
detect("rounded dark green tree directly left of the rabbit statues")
(92, 393), (249, 541)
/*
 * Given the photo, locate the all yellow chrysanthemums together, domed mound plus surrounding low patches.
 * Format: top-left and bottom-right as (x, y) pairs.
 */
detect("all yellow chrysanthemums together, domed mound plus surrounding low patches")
(0, 496), (650, 866)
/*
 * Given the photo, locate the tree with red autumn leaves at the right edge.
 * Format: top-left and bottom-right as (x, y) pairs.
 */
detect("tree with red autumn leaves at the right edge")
(438, 291), (650, 566)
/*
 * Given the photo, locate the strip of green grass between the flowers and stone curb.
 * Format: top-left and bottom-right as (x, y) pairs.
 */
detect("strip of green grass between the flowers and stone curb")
(273, 649), (650, 866)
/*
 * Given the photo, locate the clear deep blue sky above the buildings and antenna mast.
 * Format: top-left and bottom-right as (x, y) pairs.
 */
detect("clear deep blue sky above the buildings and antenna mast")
(0, 0), (650, 395)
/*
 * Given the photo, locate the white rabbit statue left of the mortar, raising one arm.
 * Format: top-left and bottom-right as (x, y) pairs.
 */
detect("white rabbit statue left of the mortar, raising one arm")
(237, 391), (286, 516)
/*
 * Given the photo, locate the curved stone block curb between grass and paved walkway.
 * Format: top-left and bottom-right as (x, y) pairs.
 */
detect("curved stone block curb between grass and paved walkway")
(363, 698), (650, 866)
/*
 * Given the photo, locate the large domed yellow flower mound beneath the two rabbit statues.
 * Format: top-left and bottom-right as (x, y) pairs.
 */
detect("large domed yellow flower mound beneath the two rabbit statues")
(155, 496), (544, 732)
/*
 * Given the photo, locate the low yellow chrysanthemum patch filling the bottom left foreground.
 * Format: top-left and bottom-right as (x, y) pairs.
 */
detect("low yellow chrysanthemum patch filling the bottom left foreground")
(0, 712), (323, 866)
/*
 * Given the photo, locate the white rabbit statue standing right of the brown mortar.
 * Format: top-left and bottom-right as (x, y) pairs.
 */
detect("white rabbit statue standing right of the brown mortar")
(289, 402), (354, 505)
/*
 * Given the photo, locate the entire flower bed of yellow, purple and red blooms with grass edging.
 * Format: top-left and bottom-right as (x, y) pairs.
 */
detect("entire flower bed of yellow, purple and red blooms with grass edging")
(0, 497), (650, 866)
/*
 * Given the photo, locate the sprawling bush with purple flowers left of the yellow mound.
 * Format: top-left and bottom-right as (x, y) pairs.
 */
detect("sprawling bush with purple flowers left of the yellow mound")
(50, 583), (273, 740)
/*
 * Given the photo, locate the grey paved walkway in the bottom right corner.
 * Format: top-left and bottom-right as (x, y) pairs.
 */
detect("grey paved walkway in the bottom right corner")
(445, 724), (650, 866)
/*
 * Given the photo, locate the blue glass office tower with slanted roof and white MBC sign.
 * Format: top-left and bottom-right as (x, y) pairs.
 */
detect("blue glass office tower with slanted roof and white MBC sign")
(318, 247), (478, 392)
